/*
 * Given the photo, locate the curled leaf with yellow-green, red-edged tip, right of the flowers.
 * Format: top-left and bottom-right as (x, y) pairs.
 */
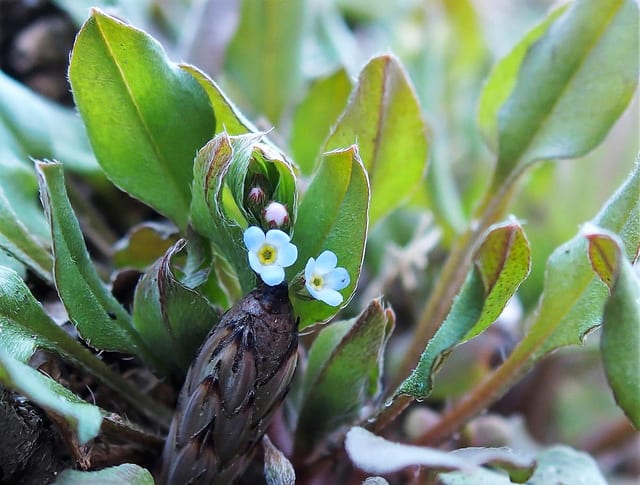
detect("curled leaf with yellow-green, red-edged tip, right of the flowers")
(396, 221), (531, 399)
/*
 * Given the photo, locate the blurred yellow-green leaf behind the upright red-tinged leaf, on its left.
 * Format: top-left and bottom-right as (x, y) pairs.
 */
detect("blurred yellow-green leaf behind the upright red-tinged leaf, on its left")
(289, 69), (352, 175)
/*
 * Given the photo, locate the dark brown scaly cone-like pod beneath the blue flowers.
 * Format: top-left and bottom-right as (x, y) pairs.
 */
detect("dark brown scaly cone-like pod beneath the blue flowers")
(162, 283), (298, 485)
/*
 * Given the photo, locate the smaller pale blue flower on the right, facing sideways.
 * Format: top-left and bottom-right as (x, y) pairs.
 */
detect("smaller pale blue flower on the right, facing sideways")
(304, 251), (351, 306)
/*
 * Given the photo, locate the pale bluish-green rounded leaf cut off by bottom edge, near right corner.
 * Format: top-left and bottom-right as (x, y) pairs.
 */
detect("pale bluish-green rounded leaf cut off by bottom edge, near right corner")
(527, 446), (607, 485)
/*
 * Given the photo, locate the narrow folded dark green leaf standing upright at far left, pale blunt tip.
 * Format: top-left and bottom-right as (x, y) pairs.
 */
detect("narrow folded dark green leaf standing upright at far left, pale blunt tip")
(36, 162), (155, 359)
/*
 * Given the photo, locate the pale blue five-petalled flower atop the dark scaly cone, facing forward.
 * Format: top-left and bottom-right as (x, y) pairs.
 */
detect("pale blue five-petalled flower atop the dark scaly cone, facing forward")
(244, 226), (298, 286)
